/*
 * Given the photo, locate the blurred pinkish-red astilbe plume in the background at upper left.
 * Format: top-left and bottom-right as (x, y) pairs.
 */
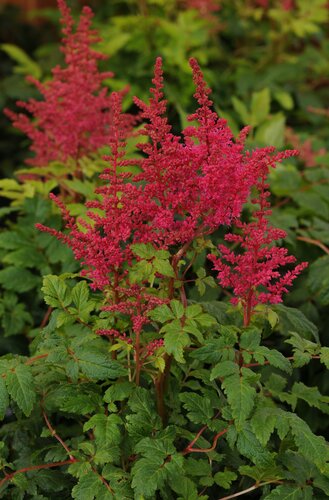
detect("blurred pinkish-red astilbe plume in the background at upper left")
(6, 0), (131, 167)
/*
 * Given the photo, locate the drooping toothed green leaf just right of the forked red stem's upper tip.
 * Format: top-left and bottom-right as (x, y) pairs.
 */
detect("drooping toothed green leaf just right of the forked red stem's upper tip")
(222, 375), (256, 431)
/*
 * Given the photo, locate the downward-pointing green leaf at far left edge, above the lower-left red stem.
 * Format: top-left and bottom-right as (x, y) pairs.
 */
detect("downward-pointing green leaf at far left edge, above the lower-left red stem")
(6, 365), (36, 417)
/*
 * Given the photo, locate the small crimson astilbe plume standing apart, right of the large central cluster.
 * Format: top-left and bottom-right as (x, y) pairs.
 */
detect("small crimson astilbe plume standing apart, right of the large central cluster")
(208, 151), (307, 326)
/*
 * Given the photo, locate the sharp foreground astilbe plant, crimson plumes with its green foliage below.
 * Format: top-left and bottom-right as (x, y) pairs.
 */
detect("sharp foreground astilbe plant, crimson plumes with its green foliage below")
(0, 49), (329, 500)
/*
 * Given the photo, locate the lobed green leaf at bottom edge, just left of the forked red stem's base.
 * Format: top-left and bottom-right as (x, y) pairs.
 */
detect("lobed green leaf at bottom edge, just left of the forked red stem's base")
(132, 437), (184, 498)
